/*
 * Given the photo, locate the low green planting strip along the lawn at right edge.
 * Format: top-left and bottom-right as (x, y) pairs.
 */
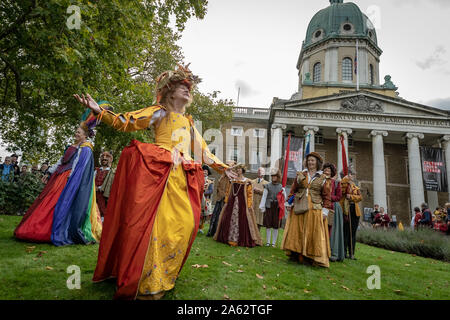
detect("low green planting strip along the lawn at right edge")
(356, 228), (450, 261)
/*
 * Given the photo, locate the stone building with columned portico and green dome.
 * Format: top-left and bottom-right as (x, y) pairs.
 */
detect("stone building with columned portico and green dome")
(219, 0), (450, 227)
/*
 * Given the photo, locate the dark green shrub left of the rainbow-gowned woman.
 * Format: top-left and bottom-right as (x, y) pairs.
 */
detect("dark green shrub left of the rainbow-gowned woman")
(0, 173), (44, 215)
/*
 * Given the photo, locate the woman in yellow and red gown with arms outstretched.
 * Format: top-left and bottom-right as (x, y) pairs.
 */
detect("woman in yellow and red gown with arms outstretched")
(74, 65), (235, 299)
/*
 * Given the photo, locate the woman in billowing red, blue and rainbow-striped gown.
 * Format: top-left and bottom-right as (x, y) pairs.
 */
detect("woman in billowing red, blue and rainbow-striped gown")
(14, 116), (102, 246)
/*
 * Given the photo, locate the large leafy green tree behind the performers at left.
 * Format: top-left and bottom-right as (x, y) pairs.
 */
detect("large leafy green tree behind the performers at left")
(0, 0), (236, 163)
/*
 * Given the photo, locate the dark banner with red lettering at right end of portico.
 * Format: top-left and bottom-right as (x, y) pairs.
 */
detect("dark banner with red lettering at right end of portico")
(420, 147), (448, 192)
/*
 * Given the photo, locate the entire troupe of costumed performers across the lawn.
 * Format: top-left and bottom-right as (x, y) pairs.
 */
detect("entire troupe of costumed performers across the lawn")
(2, 66), (398, 300)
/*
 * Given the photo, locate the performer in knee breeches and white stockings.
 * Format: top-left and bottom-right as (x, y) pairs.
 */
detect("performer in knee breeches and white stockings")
(259, 168), (286, 247)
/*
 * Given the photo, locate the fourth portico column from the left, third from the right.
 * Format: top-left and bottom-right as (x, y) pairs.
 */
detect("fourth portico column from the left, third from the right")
(370, 130), (388, 210)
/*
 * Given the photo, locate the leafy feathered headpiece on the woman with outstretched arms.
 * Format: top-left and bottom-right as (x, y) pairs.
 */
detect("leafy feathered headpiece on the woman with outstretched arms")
(156, 64), (201, 103)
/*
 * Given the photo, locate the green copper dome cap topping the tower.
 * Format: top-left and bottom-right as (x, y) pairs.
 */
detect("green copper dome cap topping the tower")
(303, 0), (381, 51)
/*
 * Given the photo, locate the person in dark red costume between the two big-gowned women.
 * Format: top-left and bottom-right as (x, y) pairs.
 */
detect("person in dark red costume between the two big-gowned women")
(95, 151), (115, 218)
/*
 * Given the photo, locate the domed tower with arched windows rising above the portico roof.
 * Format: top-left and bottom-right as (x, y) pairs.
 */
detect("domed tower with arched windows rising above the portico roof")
(296, 0), (397, 99)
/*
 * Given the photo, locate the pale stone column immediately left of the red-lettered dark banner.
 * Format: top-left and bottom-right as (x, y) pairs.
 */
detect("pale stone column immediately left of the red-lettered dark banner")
(405, 133), (425, 214)
